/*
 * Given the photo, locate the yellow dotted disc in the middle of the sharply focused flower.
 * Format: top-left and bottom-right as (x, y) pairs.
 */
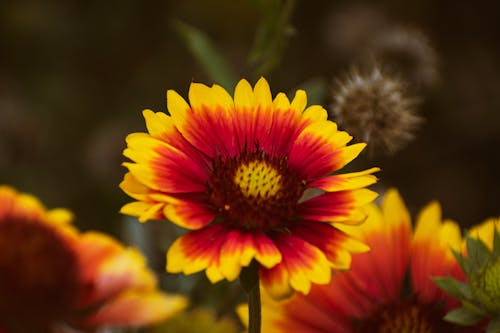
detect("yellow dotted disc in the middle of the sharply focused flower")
(233, 161), (281, 199)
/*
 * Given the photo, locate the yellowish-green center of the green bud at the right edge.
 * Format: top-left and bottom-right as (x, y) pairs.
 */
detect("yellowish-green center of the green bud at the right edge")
(471, 258), (500, 312)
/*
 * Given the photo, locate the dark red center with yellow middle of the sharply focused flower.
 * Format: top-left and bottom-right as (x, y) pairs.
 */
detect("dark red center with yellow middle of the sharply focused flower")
(207, 150), (305, 231)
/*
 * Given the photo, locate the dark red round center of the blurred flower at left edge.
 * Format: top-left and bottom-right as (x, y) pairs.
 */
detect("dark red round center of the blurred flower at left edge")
(0, 218), (79, 332)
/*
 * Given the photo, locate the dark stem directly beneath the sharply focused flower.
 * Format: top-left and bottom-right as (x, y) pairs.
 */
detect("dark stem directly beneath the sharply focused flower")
(240, 261), (261, 333)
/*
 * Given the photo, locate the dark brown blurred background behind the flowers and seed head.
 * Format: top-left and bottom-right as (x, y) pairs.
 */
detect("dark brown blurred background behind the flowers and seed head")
(0, 0), (500, 326)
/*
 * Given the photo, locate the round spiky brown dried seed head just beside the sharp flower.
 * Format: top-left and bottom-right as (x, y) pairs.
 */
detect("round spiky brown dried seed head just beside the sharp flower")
(331, 68), (421, 155)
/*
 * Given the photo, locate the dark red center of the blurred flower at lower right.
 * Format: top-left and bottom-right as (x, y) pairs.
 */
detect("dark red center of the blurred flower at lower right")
(356, 300), (456, 333)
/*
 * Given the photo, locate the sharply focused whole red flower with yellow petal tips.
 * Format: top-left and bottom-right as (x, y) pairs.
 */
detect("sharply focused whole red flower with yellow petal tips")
(120, 79), (378, 298)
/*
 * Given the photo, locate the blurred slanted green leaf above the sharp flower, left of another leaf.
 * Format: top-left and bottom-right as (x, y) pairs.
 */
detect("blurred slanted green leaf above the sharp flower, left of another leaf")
(174, 21), (236, 90)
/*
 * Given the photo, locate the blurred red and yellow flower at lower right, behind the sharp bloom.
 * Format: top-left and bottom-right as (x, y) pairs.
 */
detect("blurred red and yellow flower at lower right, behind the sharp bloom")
(244, 190), (482, 333)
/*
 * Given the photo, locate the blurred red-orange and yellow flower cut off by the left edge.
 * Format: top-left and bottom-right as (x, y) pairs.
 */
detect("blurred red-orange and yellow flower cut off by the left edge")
(0, 186), (186, 333)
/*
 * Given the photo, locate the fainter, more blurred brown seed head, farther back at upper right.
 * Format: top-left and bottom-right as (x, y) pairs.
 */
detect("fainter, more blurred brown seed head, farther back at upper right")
(368, 27), (439, 89)
